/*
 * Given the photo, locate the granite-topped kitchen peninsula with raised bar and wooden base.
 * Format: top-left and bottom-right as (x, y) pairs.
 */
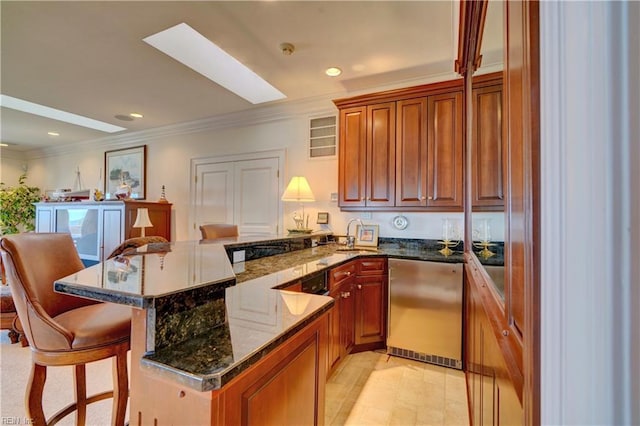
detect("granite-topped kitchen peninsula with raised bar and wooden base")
(55, 236), (476, 425)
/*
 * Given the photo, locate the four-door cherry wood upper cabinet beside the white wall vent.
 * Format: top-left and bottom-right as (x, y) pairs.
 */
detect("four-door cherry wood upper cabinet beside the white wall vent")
(334, 80), (464, 211)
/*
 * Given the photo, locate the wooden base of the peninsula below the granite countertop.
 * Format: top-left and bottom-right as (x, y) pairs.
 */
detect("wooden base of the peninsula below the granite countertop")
(129, 314), (328, 426)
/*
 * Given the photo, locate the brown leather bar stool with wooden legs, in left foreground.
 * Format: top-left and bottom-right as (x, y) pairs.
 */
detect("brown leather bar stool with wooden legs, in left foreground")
(0, 233), (131, 425)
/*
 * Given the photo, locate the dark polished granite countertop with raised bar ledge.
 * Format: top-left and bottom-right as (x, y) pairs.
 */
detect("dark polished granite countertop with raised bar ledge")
(55, 239), (476, 391)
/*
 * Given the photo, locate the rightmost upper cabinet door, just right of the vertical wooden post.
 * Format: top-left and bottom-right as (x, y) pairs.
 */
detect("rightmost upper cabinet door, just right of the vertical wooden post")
(471, 73), (504, 211)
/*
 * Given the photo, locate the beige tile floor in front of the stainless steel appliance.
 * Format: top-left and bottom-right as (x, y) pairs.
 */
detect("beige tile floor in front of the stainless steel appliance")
(325, 352), (469, 426)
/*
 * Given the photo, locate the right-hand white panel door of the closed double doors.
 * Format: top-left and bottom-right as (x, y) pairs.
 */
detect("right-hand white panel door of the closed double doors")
(234, 158), (280, 234)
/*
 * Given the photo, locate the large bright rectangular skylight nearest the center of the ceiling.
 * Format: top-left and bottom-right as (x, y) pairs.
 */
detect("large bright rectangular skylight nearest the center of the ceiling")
(143, 23), (286, 104)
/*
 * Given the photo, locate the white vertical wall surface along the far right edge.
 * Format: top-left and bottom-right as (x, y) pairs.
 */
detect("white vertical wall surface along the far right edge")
(540, 2), (640, 425)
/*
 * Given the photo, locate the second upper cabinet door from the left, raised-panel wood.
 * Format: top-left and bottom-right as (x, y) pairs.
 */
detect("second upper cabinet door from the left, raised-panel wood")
(364, 102), (396, 207)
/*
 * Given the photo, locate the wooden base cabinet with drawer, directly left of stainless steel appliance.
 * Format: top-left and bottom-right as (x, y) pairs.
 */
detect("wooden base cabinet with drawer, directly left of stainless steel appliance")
(354, 258), (388, 351)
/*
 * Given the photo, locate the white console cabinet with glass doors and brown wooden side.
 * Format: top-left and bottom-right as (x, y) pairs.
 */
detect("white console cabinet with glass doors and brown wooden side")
(35, 201), (171, 263)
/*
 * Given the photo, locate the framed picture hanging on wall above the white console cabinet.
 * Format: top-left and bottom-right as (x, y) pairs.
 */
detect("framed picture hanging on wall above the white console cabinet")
(104, 145), (147, 200)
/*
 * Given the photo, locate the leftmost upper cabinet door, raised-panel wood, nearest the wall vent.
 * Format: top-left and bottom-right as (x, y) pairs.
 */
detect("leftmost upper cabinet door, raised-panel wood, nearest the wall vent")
(338, 106), (367, 207)
